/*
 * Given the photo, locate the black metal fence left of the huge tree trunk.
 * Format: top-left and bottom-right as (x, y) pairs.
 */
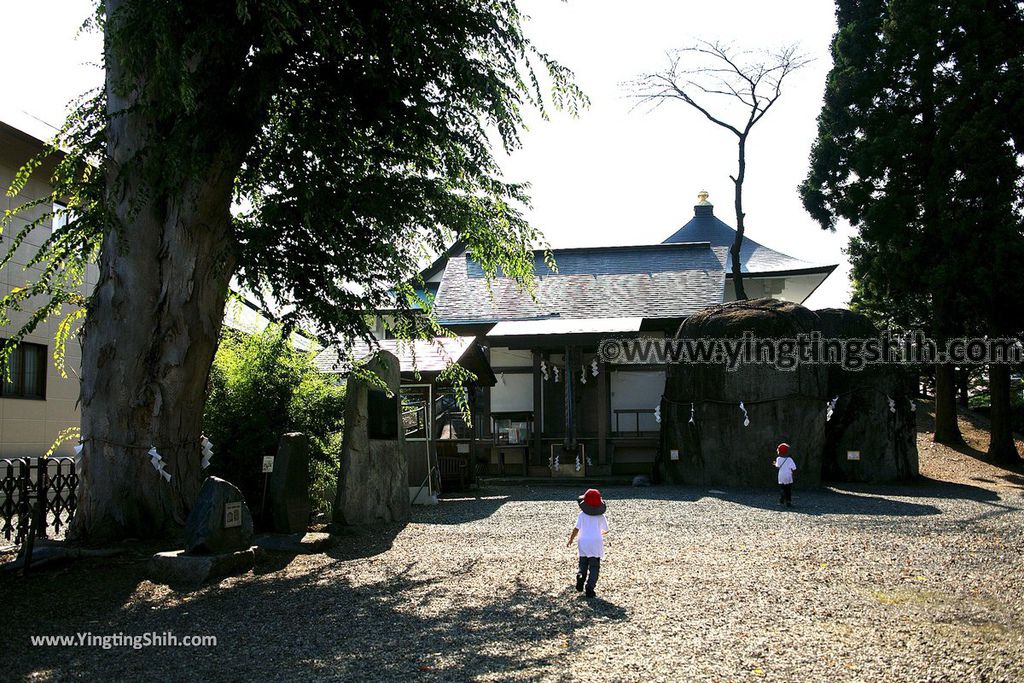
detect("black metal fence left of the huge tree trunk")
(0, 458), (78, 545)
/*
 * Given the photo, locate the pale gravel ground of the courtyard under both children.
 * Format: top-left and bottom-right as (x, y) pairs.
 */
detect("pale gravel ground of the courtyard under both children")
(0, 403), (1024, 681)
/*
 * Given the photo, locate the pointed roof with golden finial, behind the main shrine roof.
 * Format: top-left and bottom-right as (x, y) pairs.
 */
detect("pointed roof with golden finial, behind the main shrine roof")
(663, 204), (835, 273)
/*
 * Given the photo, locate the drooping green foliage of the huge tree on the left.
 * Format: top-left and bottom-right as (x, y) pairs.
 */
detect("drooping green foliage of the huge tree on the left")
(0, 0), (586, 368)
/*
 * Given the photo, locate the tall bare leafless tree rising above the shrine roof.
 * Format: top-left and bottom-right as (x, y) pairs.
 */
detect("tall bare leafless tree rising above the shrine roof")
(630, 41), (810, 299)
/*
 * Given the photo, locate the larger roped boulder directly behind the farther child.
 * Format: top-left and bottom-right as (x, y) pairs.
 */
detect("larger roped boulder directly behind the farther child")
(656, 299), (827, 486)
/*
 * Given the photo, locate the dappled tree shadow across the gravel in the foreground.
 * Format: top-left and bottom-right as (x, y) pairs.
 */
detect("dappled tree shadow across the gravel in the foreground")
(4, 552), (627, 681)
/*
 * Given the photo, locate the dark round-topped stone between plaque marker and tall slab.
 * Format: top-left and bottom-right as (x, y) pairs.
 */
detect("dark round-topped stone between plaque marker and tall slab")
(270, 432), (311, 533)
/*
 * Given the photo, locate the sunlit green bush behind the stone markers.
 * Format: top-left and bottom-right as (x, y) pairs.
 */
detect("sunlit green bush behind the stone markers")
(203, 326), (345, 518)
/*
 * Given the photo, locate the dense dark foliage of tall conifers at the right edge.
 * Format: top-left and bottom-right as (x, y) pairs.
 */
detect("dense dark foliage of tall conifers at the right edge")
(801, 0), (1024, 336)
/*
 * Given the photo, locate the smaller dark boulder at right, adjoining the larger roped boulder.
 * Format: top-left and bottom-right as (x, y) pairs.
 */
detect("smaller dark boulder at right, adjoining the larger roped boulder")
(817, 308), (919, 482)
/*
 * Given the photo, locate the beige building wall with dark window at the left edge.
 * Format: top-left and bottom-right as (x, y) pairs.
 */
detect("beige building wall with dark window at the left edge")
(0, 130), (97, 458)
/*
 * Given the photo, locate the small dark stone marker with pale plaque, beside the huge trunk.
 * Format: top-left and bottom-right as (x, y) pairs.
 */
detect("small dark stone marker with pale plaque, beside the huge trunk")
(184, 476), (253, 555)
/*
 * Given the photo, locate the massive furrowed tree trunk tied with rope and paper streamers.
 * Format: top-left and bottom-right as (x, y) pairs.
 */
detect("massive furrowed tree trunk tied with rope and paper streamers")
(70, 9), (233, 543)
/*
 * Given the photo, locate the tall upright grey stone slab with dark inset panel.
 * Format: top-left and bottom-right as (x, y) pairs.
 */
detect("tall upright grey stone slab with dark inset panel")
(334, 351), (410, 525)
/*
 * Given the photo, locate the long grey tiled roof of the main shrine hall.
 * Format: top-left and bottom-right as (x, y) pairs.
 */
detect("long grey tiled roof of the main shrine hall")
(434, 243), (725, 325)
